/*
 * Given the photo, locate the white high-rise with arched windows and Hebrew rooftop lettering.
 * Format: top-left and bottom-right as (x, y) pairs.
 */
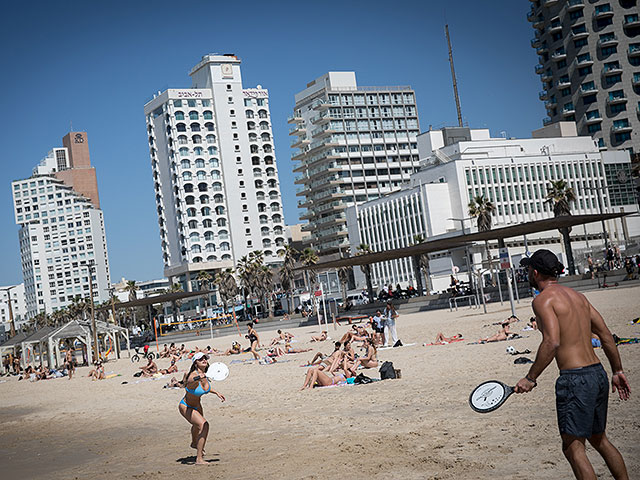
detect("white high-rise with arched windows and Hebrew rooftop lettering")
(144, 54), (286, 290)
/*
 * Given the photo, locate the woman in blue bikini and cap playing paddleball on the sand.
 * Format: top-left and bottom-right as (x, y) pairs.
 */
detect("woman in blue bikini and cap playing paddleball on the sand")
(178, 352), (225, 465)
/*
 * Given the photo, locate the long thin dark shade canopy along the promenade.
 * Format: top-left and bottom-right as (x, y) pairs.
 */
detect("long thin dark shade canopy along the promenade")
(296, 212), (632, 270)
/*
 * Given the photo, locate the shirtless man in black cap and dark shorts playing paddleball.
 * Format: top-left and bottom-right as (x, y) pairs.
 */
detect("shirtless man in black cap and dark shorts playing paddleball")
(515, 250), (631, 480)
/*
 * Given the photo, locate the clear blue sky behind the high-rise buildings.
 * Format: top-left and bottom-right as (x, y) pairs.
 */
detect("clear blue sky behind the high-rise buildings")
(0, 0), (545, 285)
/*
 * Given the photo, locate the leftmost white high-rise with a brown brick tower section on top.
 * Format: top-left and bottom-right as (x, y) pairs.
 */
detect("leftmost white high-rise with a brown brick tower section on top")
(11, 132), (110, 318)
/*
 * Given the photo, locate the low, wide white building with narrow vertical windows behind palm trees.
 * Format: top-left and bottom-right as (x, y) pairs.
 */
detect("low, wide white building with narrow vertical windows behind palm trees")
(347, 128), (640, 290)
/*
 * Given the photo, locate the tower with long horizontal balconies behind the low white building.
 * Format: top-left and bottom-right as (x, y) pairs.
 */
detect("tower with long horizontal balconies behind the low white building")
(289, 72), (420, 256)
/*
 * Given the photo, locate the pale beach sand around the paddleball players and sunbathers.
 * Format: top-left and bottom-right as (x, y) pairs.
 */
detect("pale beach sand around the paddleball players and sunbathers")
(0, 287), (640, 479)
